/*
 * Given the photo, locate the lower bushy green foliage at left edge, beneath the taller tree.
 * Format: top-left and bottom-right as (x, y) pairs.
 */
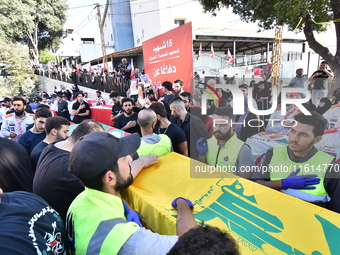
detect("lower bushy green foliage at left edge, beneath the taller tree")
(0, 36), (35, 96)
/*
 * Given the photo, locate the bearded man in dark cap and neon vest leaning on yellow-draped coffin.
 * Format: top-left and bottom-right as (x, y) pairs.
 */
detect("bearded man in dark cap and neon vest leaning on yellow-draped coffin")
(66, 132), (196, 255)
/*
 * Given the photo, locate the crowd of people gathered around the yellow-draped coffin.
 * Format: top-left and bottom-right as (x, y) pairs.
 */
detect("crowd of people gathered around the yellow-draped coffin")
(0, 60), (340, 254)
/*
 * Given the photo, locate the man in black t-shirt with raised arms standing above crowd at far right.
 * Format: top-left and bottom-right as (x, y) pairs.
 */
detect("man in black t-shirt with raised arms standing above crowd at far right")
(309, 61), (334, 105)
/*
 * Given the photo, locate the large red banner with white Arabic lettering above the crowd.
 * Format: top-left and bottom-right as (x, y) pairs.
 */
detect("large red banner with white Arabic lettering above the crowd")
(143, 22), (194, 91)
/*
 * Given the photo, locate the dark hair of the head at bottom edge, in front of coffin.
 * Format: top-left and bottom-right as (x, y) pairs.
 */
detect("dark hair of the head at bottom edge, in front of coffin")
(167, 223), (240, 255)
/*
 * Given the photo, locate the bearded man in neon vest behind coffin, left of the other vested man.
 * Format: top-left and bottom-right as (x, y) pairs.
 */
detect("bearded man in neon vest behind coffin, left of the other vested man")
(196, 106), (255, 179)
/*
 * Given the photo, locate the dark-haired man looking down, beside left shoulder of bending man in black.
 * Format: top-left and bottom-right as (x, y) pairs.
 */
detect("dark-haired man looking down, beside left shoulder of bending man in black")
(30, 116), (70, 171)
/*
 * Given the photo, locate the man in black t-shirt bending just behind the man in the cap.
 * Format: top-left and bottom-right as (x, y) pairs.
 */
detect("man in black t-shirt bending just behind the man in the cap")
(33, 120), (104, 220)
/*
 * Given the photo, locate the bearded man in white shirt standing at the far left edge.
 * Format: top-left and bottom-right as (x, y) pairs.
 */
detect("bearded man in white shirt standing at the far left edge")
(1, 97), (34, 141)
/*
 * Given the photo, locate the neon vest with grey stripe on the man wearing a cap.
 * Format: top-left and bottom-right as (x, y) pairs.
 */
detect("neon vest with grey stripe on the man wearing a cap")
(66, 187), (140, 255)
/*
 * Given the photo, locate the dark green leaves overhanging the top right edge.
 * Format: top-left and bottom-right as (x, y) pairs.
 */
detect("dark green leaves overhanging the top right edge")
(199, 0), (333, 31)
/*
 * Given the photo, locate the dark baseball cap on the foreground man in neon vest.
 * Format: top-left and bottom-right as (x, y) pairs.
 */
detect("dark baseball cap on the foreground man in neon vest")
(68, 132), (141, 181)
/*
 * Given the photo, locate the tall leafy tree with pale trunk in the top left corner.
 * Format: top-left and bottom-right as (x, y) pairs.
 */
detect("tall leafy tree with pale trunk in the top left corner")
(0, 0), (66, 62)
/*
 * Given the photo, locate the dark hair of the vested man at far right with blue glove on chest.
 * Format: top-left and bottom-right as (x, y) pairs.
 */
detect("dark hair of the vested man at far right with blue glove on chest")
(294, 111), (327, 137)
